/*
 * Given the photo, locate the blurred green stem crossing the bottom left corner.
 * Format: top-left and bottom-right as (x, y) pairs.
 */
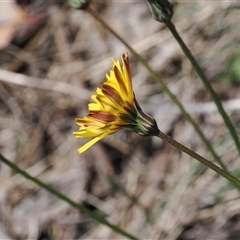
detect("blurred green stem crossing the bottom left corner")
(0, 154), (138, 240)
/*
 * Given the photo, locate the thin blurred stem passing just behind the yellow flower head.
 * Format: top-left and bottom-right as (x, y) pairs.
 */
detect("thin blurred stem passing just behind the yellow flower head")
(87, 7), (227, 171)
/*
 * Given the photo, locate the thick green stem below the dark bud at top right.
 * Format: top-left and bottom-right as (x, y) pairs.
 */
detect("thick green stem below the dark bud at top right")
(164, 19), (240, 158)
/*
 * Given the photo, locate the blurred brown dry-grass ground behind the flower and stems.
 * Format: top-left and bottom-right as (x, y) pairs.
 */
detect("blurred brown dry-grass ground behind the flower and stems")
(0, 0), (240, 240)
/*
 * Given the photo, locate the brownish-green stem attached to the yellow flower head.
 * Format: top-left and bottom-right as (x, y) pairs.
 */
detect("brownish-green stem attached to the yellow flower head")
(157, 131), (240, 190)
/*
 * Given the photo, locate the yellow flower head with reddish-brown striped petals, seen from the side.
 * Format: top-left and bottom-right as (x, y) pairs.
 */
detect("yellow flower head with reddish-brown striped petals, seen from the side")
(73, 53), (159, 153)
